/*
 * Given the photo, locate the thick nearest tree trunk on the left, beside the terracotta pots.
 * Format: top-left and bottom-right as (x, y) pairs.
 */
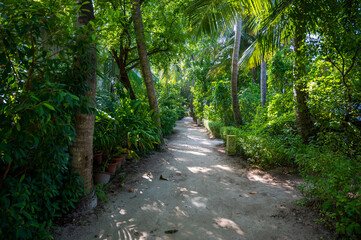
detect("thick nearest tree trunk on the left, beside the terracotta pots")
(70, 0), (97, 211)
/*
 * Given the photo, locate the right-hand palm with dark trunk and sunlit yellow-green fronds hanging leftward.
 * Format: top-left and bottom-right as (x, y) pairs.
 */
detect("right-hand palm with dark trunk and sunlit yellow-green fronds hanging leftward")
(245, 0), (315, 142)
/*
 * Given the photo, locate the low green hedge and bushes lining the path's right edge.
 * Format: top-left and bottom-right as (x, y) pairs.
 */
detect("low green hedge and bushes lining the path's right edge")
(203, 117), (361, 236)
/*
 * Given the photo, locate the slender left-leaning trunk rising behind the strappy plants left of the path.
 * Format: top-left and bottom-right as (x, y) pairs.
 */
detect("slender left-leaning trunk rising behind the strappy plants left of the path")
(132, 0), (163, 143)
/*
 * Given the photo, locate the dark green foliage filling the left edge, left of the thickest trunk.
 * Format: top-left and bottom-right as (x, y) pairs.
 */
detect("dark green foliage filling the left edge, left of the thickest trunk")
(0, 0), (91, 239)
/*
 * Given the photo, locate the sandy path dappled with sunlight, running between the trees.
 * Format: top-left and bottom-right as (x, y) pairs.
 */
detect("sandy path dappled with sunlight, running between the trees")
(54, 118), (331, 240)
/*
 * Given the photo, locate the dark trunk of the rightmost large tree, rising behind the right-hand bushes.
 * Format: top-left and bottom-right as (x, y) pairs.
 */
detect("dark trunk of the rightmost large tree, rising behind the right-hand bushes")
(293, 16), (314, 143)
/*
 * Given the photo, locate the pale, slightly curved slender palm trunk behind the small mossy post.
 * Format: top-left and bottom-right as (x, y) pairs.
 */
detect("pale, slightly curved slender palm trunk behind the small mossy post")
(231, 19), (242, 126)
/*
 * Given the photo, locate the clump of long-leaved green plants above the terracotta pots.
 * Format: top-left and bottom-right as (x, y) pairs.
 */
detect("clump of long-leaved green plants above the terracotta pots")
(94, 92), (160, 154)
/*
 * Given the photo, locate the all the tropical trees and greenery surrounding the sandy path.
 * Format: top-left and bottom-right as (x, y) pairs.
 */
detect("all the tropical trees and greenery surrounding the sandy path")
(0, 0), (361, 239)
